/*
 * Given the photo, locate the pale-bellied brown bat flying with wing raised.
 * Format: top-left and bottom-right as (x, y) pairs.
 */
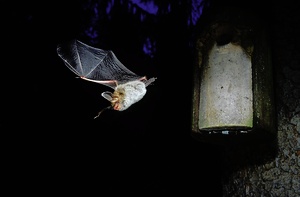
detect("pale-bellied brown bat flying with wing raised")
(57, 39), (156, 118)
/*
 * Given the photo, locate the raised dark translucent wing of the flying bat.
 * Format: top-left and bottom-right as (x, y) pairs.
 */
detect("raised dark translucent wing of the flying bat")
(57, 40), (141, 88)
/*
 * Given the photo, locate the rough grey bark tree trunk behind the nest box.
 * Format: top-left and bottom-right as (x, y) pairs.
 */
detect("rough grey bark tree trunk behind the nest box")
(223, 4), (300, 197)
